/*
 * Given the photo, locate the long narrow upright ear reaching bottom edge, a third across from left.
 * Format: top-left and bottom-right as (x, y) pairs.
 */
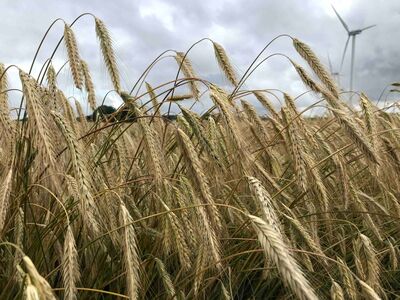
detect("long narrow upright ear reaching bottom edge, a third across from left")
(119, 202), (140, 299)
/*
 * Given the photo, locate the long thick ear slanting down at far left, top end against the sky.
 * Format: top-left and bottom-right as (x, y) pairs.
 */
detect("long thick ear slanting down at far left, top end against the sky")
(19, 70), (55, 166)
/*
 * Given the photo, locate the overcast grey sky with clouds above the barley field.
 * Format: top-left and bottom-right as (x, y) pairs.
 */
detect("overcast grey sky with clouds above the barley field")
(0, 0), (400, 110)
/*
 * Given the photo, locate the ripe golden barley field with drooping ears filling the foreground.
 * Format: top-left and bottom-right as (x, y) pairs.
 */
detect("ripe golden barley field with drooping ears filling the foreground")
(0, 18), (400, 299)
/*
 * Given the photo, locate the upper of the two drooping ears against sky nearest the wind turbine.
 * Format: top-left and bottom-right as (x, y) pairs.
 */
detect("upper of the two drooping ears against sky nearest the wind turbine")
(293, 38), (339, 98)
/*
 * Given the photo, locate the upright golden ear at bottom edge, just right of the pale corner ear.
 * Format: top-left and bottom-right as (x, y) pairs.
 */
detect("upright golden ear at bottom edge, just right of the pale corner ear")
(61, 225), (80, 300)
